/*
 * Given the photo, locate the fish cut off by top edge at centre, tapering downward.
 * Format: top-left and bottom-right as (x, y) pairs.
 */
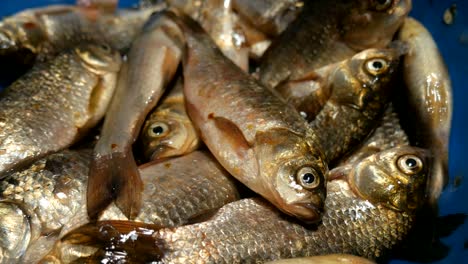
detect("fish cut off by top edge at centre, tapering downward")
(232, 0), (304, 37)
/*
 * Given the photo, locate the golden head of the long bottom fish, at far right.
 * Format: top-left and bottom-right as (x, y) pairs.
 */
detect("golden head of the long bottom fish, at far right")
(349, 146), (430, 212)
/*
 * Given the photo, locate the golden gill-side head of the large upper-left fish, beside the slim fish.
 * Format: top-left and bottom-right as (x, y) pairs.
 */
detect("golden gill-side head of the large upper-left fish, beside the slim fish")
(74, 43), (122, 75)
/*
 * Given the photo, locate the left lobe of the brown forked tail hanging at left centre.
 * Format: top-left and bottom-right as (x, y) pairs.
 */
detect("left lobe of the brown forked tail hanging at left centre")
(86, 154), (115, 221)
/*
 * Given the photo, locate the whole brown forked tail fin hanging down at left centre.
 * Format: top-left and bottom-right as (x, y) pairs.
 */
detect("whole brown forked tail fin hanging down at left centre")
(87, 151), (143, 220)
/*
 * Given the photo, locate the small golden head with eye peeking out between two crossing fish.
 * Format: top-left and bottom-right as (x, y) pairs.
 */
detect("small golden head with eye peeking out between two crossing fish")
(141, 109), (198, 160)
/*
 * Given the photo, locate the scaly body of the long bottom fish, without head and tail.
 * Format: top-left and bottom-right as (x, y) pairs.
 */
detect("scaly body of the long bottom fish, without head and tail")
(156, 180), (412, 263)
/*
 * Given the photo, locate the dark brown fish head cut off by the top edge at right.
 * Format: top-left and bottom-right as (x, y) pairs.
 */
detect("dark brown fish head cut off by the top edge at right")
(343, 0), (412, 50)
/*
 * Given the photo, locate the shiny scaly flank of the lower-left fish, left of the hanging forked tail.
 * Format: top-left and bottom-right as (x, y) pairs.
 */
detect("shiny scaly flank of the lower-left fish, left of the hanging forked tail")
(0, 151), (91, 232)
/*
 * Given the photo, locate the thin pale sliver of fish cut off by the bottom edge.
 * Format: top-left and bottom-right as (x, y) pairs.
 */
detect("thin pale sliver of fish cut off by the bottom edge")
(265, 254), (376, 264)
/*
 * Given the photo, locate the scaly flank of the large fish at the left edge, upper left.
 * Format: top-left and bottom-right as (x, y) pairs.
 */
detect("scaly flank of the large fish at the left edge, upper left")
(0, 51), (99, 174)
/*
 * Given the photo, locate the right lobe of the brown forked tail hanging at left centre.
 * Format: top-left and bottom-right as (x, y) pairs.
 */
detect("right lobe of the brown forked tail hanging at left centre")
(111, 151), (143, 220)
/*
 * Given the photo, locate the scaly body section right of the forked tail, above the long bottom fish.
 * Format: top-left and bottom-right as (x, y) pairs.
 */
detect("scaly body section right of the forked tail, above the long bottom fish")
(128, 151), (239, 227)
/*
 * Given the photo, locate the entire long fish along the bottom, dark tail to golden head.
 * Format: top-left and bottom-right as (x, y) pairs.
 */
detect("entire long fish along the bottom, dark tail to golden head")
(62, 146), (430, 263)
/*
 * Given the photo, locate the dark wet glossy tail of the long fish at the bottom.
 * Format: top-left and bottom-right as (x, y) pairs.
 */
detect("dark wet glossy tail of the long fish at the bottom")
(61, 220), (166, 263)
